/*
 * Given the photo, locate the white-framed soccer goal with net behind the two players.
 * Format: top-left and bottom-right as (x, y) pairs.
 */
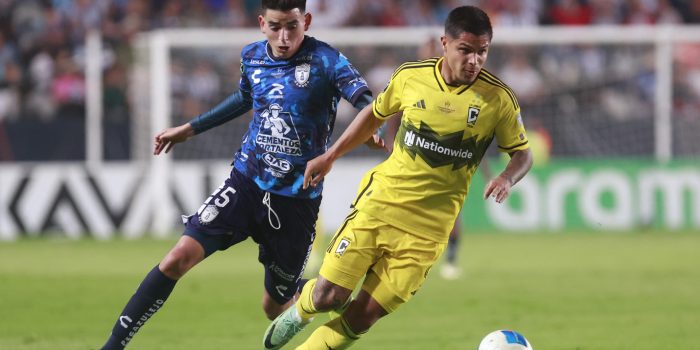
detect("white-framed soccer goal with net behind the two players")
(131, 27), (700, 234)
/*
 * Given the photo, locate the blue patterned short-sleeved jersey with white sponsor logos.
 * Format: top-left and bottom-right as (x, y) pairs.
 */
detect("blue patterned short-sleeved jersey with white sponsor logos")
(234, 36), (368, 198)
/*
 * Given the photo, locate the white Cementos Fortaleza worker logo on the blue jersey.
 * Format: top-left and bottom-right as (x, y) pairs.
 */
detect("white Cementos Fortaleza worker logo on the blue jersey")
(255, 103), (301, 156)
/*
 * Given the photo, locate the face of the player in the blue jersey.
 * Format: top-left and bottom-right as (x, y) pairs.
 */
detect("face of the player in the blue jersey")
(258, 8), (311, 58)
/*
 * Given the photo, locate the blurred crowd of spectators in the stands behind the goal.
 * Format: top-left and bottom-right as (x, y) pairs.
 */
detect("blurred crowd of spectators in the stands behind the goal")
(0, 0), (700, 160)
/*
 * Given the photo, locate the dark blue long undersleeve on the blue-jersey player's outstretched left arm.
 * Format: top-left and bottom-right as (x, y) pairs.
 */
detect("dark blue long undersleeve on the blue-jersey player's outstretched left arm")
(190, 90), (253, 134)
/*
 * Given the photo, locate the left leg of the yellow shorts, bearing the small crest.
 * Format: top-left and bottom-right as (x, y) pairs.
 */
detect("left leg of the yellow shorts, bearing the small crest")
(319, 210), (385, 290)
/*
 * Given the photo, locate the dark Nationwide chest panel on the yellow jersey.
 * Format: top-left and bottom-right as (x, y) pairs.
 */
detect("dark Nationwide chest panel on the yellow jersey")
(397, 122), (491, 170)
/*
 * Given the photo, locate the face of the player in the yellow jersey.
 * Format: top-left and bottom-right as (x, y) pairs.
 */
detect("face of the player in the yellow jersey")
(440, 32), (491, 85)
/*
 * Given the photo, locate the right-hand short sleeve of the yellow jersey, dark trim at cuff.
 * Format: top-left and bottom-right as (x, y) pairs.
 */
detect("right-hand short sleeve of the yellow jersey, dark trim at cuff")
(496, 99), (530, 153)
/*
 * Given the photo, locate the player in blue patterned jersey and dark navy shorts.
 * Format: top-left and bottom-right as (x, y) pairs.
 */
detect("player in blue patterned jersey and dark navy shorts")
(102, 0), (383, 350)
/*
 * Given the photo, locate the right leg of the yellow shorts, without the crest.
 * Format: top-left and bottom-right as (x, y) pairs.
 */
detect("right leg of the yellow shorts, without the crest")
(362, 231), (446, 312)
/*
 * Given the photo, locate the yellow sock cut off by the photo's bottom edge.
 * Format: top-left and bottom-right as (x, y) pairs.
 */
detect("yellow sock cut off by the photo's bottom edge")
(296, 316), (360, 350)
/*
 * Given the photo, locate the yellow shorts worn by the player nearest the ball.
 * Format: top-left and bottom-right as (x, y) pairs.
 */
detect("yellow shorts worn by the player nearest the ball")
(319, 210), (447, 312)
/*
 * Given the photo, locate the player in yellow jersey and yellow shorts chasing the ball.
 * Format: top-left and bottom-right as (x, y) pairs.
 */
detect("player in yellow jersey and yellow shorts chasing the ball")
(263, 6), (532, 349)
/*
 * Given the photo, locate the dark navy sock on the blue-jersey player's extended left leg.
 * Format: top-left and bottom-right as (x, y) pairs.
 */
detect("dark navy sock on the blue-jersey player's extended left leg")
(102, 265), (177, 350)
